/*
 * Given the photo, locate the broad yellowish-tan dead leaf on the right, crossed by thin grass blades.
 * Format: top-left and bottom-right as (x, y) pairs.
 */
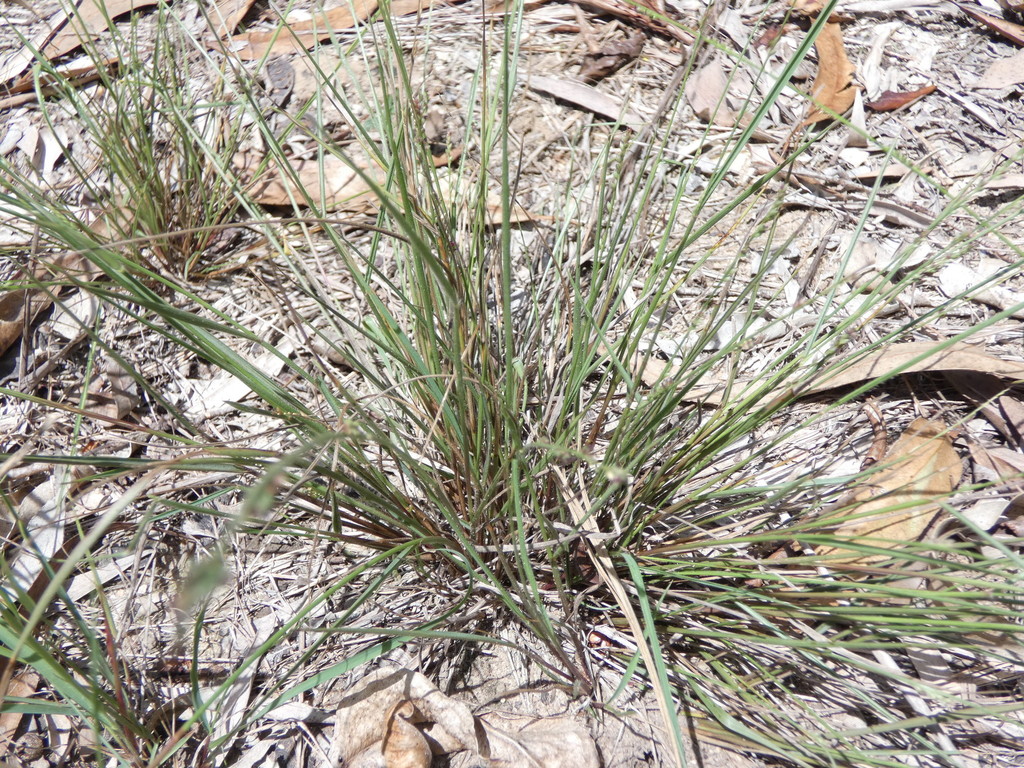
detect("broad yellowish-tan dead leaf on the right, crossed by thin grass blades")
(816, 419), (963, 565)
